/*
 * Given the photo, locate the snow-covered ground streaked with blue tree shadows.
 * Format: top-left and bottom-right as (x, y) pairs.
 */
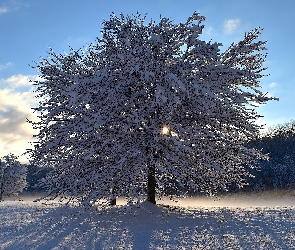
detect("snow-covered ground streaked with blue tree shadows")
(0, 191), (295, 250)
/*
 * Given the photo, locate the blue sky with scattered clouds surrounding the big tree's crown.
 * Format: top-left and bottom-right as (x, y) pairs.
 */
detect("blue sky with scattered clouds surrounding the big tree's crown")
(0, 0), (295, 162)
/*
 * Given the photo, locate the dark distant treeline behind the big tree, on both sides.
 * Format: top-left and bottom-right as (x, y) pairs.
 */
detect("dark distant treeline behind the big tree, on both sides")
(26, 120), (295, 192)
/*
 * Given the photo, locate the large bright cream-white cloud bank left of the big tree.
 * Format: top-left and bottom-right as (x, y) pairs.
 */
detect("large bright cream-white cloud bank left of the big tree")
(0, 75), (38, 162)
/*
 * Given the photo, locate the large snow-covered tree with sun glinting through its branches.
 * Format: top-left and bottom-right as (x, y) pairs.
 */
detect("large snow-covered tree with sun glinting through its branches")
(27, 13), (278, 204)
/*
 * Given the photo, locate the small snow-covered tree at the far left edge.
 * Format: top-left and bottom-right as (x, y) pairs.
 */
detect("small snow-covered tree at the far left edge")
(0, 154), (27, 201)
